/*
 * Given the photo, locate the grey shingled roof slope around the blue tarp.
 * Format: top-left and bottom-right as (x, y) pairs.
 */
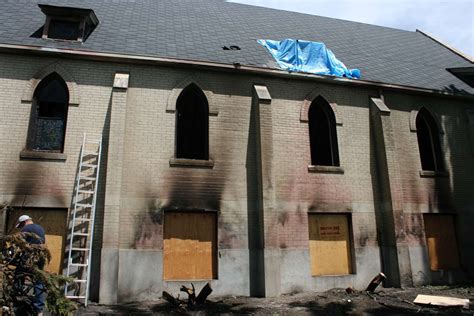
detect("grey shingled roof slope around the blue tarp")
(0, 0), (474, 93)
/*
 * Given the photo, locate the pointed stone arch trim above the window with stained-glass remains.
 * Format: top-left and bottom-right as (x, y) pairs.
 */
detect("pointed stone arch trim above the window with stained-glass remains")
(21, 63), (80, 106)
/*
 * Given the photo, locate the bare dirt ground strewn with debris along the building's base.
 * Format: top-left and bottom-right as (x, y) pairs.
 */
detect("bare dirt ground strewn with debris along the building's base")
(77, 285), (474, 316)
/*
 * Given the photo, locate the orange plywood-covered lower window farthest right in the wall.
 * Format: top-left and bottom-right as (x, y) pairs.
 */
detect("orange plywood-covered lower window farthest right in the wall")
(423, 214), (459, 271)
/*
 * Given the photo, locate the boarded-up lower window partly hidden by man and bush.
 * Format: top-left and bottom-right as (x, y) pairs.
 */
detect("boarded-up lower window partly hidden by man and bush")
(7, 208), (67, 274)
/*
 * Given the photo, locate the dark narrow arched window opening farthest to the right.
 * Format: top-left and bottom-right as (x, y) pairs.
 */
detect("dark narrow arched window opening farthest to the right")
(416, 108), (444, 171)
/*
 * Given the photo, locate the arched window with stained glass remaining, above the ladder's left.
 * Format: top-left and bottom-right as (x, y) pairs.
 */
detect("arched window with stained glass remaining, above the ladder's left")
(28, 73), (69, 152)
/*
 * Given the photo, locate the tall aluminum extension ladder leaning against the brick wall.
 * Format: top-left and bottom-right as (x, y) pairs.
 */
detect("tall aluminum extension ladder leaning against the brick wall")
(64, 134), (102, 306)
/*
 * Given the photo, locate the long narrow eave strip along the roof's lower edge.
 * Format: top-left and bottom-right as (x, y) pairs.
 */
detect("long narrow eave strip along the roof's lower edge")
(0, 43), (474, 99)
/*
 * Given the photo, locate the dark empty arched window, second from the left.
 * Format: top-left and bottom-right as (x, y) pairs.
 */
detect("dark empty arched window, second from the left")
(176, 84), (209, 160)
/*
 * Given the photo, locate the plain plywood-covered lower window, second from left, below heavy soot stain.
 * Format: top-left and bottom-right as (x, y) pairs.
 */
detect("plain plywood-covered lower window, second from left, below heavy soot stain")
(163, 212), (217, 280)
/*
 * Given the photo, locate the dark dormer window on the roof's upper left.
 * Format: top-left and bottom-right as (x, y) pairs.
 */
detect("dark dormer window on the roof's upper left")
(38, 4), (99, 42)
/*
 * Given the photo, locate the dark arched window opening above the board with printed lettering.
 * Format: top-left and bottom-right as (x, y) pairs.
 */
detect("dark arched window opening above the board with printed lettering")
(308, 96), (339, 166)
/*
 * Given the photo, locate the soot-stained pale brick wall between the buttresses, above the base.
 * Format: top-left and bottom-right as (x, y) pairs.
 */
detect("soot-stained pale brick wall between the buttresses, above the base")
(0, 54), (474, 298)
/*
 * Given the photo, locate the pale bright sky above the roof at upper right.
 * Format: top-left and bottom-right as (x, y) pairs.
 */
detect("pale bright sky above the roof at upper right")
(230, 0), (474, 56)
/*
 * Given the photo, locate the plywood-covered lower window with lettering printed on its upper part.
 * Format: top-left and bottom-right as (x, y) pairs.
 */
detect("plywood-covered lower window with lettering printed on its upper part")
(308, 214), (352, 276)
